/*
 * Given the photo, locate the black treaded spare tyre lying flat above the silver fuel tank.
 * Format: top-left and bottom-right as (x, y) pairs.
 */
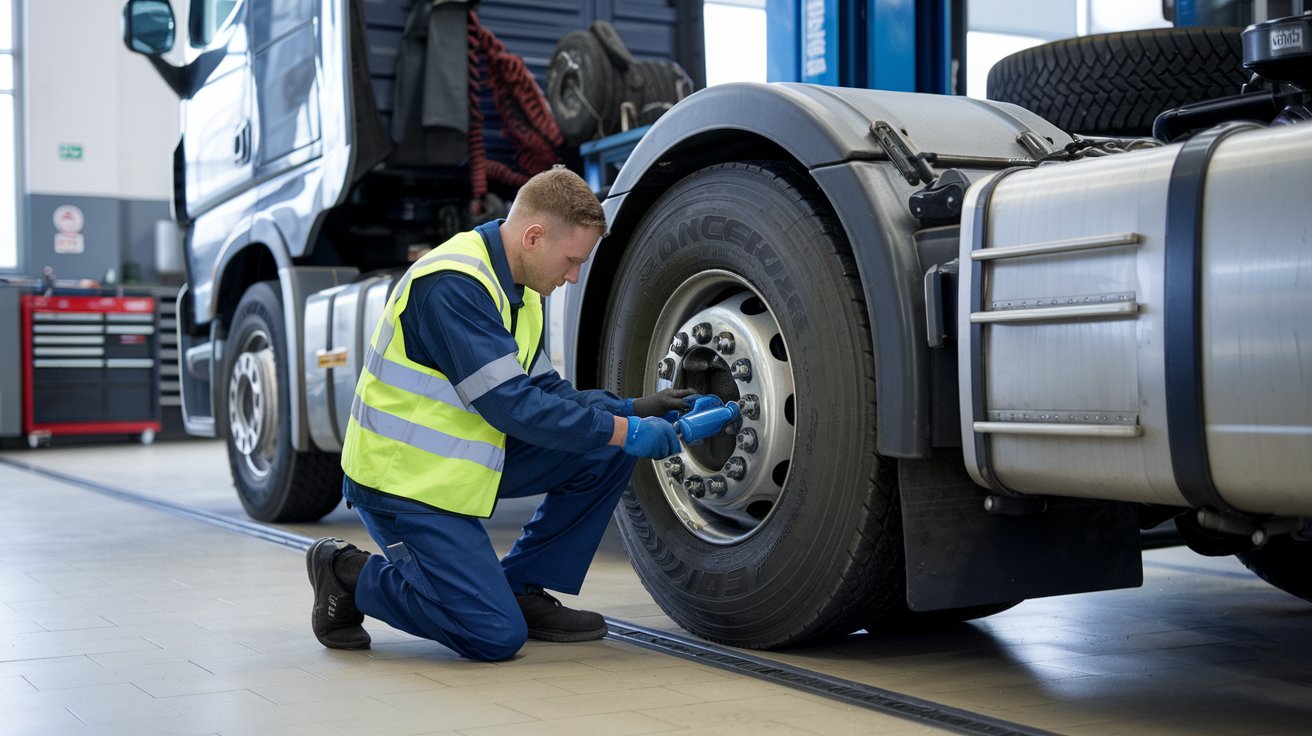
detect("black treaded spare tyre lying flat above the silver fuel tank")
(988, 28), (1249, 136)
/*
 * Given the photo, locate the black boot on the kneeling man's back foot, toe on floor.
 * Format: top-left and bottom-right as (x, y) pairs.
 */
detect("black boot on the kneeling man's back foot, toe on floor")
(306, 537), (370, 649)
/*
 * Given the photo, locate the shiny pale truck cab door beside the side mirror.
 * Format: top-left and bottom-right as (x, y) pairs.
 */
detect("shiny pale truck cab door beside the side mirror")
(182, 0), (256, 216)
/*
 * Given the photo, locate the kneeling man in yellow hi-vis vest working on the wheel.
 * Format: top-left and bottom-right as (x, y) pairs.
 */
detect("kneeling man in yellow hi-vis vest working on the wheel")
(306, 167), (695, 661)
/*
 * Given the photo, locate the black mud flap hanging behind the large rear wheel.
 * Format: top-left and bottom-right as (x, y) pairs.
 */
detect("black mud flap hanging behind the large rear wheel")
(897, 449), (1143, 611)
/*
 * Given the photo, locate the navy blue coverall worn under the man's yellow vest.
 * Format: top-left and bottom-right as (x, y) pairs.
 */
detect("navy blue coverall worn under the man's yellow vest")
(342, 220), (636, 660)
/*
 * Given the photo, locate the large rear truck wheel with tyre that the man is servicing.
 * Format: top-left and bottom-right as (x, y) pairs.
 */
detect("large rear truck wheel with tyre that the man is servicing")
(601, 163), (905, 648)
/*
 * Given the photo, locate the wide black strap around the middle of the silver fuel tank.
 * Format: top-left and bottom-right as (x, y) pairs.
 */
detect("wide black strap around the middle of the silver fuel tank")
(1162, 123), (1258, 510)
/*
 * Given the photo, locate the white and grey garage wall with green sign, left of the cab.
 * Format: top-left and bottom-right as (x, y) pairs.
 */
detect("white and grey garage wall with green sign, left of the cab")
(20, 0), (178, 282)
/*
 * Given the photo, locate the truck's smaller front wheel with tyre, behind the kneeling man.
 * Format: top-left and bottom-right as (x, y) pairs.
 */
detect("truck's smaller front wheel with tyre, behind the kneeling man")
(218, 281), (341, 522)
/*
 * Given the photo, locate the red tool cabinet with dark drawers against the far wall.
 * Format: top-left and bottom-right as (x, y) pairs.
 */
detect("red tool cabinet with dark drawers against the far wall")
(22, 295), (160, 446)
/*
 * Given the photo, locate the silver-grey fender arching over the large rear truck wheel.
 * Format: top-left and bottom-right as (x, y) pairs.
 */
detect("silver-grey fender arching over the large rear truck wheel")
(579, 83), (1071, 458)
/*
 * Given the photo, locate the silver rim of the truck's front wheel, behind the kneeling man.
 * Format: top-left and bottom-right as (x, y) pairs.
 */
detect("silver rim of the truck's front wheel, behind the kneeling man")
(228, 332), (278, 479)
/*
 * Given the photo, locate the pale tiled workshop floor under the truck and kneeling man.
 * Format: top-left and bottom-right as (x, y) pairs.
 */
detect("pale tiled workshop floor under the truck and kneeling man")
(0, 441), (1312, 736)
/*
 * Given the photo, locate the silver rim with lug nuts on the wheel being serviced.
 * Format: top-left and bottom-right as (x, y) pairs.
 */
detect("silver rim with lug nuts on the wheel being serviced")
(646, 270), (795, 544)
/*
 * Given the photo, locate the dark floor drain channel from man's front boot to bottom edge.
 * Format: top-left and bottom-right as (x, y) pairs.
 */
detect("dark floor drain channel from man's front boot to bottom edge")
(606, 618), (1052, 736)
